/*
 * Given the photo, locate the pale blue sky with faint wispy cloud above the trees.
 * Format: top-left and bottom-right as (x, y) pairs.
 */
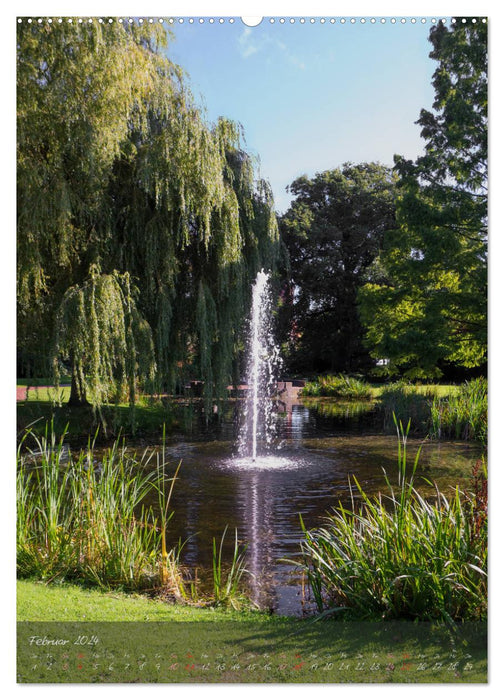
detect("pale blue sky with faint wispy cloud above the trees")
(168, 17), (435, 212)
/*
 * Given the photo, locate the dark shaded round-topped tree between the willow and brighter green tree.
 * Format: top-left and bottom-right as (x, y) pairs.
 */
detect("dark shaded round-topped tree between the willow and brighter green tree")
(281, 163), (395, 372)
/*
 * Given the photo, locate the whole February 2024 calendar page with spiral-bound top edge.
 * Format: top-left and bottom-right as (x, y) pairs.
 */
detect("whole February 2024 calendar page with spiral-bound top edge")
(15, 7), (488, 684)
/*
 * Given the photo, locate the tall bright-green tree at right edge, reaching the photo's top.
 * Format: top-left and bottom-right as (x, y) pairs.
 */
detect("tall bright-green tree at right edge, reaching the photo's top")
(360, 19), (487, 376)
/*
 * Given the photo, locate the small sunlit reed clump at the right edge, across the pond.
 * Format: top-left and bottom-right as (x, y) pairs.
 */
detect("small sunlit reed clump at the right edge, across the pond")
(431, 377), (488, 444)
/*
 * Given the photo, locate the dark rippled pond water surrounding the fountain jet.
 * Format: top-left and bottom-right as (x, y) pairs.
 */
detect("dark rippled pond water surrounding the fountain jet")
(144, 402), (481, 615)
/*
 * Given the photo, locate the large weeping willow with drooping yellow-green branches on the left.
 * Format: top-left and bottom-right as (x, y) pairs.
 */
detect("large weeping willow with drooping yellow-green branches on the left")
(17, 19), (278, 405)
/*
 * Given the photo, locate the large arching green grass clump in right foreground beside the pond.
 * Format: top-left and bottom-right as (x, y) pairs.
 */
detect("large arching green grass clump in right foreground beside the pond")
(302, 423), (487, 620)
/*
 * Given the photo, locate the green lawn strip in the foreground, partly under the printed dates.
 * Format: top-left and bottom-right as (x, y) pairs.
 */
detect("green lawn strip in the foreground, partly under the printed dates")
(17, 581), (487, 683)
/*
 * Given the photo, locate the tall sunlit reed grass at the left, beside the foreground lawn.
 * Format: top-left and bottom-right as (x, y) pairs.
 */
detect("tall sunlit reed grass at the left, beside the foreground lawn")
(17, 422), (184, 593)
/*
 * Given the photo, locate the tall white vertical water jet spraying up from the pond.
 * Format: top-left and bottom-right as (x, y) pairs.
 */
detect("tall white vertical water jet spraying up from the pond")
(239, 270), (279, 463)
